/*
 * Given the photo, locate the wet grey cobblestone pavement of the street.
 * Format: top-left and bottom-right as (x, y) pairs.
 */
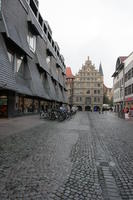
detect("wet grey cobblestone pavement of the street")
(0, 112), (133, 200)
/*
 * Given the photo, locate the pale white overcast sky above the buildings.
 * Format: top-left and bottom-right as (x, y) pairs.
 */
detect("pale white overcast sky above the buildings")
(39, 0), (133, 87)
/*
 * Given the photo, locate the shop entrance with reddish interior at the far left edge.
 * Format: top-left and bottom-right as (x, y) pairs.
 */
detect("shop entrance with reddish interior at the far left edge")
(0, 96), (8, 117)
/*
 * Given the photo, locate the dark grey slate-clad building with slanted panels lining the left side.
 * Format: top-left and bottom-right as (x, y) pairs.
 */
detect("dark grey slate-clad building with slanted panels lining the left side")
(0, 0), (67, 117)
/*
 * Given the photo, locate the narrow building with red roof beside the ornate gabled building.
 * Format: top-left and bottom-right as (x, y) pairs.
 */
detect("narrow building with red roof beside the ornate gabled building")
(66, 67), (74, 106)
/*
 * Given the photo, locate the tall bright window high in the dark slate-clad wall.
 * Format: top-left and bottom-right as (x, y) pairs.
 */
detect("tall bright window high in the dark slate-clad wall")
(27, 32), (36, 52)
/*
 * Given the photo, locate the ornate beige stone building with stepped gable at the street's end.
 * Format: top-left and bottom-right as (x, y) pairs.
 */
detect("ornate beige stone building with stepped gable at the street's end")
(73, 57), (103, 111)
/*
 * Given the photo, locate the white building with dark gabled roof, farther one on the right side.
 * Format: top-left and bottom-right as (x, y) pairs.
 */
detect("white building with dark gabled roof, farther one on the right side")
(112, 56), (127, 112)
